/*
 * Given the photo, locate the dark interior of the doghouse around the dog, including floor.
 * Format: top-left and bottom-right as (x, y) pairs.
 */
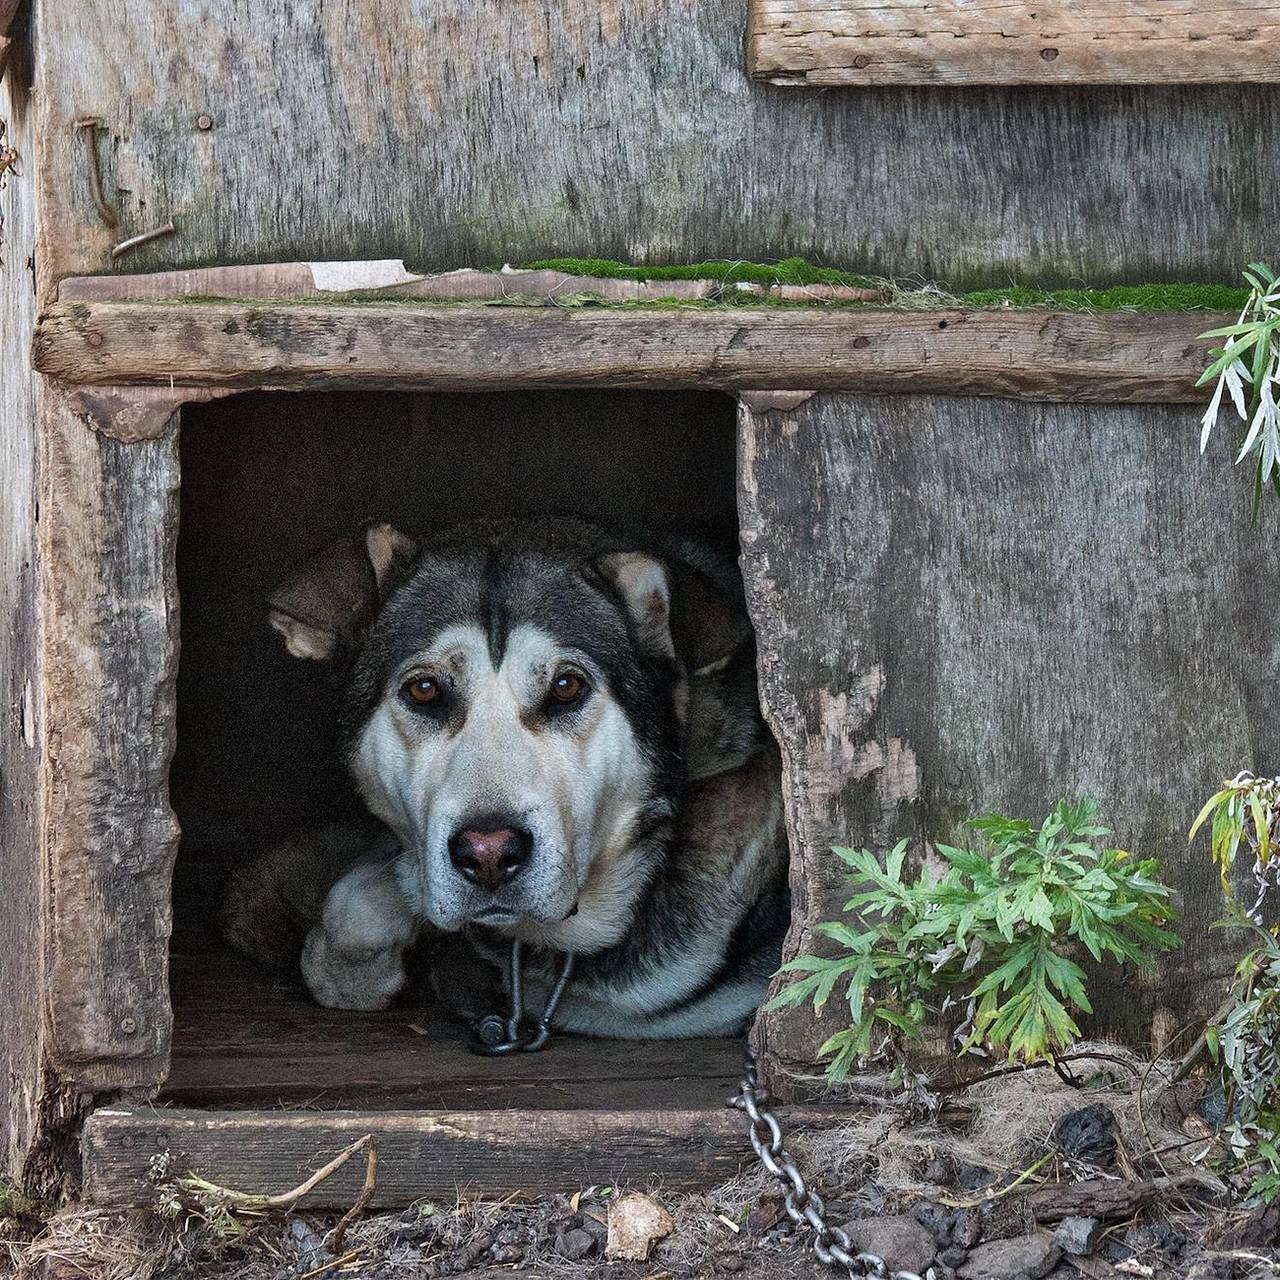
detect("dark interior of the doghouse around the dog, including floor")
(161, 392), (740, 1110)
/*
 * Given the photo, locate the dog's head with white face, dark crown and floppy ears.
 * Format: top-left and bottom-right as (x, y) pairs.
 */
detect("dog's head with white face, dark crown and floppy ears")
(271, 522), (737, 948)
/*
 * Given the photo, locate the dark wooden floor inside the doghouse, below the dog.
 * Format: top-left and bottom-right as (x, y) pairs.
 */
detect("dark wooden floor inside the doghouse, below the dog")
(157, 936), (742, 1111)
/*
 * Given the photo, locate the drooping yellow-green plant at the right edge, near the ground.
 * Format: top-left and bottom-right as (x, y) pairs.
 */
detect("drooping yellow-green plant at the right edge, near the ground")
(1190, 773), (1280, 1203)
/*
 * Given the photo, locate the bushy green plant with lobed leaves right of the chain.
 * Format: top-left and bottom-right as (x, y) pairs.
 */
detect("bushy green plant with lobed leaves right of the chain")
(773, 800), (1178, 1082)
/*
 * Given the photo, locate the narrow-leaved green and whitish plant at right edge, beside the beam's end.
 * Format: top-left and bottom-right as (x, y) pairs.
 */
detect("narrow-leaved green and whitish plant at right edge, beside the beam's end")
(1196, 262), (1280, 518)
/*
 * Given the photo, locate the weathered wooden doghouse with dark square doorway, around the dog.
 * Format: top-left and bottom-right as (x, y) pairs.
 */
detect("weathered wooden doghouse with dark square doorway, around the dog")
(0, 0), (1280, 1204)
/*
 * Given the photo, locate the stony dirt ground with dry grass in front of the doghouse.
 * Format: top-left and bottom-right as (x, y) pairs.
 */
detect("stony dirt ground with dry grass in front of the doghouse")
(0, 1046), (1280, 1280)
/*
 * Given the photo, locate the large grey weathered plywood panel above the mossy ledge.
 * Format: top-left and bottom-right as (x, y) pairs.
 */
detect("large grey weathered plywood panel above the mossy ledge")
(22, 0), (1280, 288)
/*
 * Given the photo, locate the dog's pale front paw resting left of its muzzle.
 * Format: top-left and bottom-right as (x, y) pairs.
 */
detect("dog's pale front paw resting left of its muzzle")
(302, 861), (417, 1010)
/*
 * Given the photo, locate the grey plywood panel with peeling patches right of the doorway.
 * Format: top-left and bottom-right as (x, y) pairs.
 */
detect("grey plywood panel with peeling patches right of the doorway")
(739, 396), (1280, 1090)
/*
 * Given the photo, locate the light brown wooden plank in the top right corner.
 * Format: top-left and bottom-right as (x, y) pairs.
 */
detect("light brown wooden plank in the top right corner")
(748, 0), (1280, 86)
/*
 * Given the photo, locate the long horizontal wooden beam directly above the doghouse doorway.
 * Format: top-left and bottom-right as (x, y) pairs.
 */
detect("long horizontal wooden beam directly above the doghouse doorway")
(35, 302), (1225, 402)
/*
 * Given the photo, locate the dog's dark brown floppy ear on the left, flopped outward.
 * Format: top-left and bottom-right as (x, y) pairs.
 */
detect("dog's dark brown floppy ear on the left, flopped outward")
(269, 525), (417, 660)
